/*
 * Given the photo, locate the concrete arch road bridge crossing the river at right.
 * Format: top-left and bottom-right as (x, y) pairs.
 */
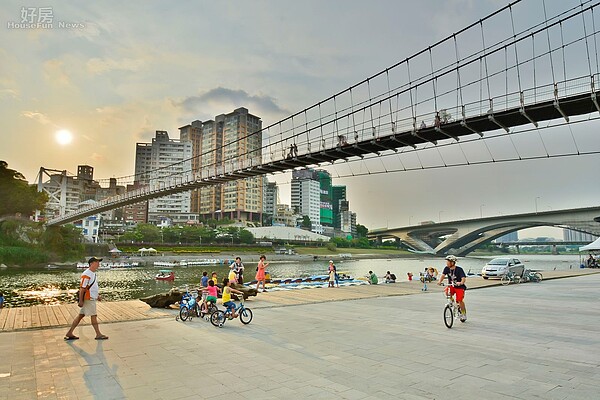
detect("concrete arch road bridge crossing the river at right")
(368, 207), (600, 256)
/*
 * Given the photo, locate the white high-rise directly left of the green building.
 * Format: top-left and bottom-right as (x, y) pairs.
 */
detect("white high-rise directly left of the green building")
(292, 169), (321, 231)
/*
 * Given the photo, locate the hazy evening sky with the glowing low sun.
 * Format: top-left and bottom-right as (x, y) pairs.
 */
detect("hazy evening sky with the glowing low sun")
(0, 0), (600, 236)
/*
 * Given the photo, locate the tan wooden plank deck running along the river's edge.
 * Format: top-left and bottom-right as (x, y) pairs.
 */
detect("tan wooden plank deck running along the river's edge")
(0, 269), (600, 332)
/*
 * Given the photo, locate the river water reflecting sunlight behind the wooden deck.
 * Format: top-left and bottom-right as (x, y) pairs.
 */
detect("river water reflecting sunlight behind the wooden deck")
(0, 254), (580, 307)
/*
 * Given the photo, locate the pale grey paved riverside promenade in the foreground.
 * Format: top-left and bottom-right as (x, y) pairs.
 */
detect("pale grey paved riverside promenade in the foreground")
(0, 270), (600, 400)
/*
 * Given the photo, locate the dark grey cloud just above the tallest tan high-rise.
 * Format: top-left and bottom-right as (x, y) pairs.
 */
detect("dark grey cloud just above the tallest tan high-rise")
(175, 87), (291, 119)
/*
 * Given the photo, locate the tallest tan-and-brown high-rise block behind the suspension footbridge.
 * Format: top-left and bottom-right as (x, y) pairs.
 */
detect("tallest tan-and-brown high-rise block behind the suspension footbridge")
(179, 108), (264, 221)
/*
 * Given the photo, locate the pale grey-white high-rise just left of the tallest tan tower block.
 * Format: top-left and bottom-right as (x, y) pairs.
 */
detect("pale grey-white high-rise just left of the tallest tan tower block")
(135, 131), (195, 223)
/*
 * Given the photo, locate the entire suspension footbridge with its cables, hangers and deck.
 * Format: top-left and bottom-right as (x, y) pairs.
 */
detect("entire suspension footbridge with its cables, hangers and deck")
(47, 0), (600, 225)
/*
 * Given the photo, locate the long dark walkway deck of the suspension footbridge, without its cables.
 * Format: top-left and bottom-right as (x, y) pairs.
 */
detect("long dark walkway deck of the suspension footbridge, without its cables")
(47, 83), (600, 225)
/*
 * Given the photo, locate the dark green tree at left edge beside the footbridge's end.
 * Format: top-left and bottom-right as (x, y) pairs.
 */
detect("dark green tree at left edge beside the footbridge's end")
(0, 160), (48, 216)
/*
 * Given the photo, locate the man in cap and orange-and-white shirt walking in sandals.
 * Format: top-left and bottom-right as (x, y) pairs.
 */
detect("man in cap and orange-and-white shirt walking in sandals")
(64, 257), (108, 340)
